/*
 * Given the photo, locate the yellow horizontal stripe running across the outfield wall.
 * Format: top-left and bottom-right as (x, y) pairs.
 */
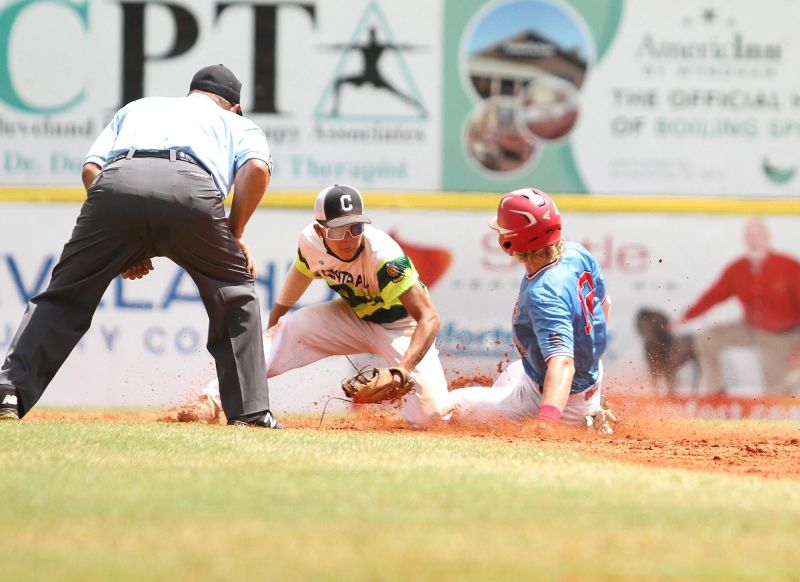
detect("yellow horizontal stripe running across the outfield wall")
(0, 187), (800, 214)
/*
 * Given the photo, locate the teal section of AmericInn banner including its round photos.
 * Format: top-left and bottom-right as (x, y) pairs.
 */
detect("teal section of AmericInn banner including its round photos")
(442, 0), (622, 192)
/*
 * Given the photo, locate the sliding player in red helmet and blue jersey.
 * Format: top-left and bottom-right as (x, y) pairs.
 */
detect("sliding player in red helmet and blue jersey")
(450, 188), (616, 433)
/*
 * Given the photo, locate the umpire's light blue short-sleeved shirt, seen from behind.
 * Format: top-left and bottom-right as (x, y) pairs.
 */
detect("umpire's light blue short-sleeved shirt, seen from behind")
(84, 93), (272, 198)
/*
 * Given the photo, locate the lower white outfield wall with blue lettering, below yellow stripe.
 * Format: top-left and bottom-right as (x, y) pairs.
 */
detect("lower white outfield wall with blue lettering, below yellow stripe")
(0, 194), (798, 410)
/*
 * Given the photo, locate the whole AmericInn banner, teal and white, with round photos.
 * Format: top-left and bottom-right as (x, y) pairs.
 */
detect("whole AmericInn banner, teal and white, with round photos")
(443, 0), (800, 197)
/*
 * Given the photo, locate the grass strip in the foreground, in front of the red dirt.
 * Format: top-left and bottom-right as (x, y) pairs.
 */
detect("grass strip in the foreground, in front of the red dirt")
(0, 421), (800, 581)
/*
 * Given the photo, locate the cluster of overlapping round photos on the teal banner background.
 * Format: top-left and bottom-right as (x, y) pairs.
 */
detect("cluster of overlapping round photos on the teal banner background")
(462, 0), (590, 173)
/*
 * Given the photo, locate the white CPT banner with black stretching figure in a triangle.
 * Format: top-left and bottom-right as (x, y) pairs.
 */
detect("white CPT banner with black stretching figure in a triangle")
(0, 0), (442, 190)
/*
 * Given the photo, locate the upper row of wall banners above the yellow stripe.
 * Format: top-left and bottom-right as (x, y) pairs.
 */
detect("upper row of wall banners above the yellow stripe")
(0, 0), (800, 197)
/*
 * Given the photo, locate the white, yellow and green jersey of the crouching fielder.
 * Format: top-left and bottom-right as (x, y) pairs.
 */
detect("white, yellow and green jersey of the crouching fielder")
(295, 223), (419, 323)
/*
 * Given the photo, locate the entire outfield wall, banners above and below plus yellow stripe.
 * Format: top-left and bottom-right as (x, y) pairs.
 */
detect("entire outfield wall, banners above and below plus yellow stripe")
(0, 0), (800, 408)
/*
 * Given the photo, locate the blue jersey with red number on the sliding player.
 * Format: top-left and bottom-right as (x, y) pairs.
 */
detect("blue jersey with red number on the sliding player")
(513, 242), (606, 394)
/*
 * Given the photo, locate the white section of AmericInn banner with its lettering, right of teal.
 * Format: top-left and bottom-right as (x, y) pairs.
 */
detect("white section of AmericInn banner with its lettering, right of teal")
(573, 0), (800, 196)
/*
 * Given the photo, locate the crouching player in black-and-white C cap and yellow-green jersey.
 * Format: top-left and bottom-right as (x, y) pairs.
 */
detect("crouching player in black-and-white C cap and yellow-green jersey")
(197, 185), (449, 427)
